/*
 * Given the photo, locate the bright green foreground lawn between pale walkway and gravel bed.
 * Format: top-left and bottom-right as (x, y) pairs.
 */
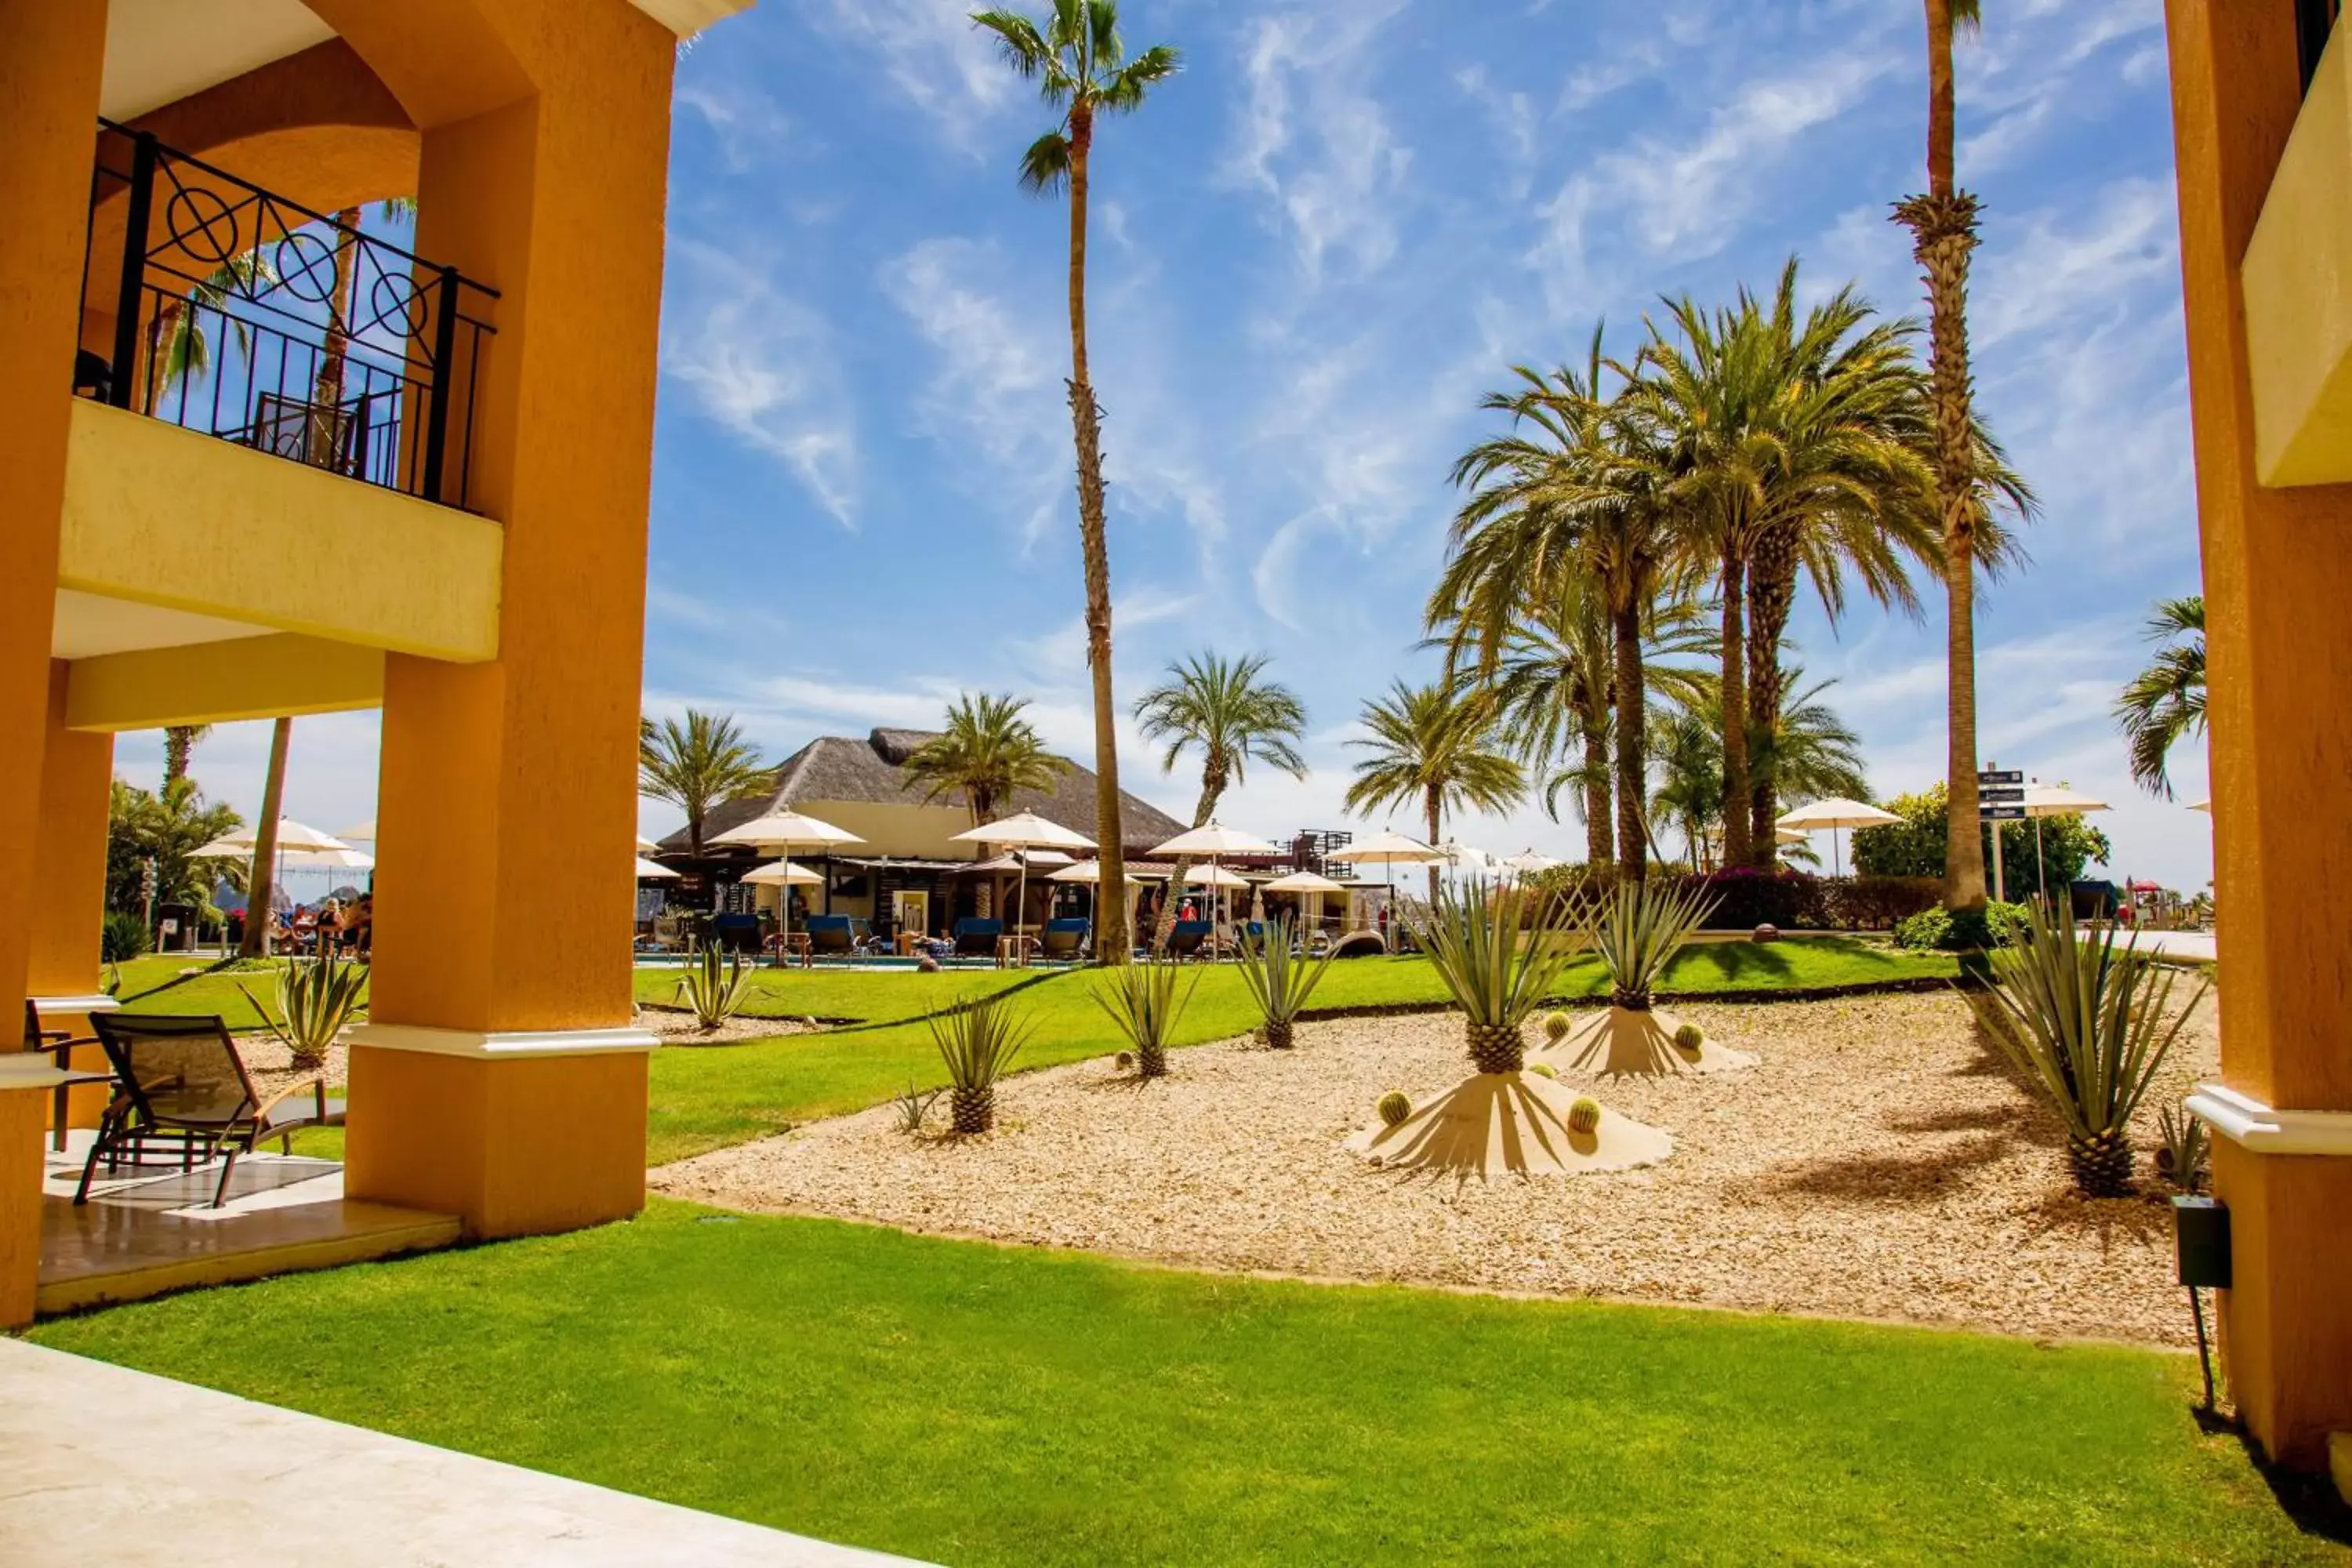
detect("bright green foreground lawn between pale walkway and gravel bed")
(31, 1203), (2343, 1568)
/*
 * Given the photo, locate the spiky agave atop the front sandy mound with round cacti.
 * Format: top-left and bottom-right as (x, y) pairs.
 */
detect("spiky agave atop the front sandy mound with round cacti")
(1406, 877), (1576, 1072)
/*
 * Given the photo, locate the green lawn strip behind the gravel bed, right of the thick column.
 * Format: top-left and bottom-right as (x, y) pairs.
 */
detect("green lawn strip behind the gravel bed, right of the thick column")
(647, 938), (1957, 1166)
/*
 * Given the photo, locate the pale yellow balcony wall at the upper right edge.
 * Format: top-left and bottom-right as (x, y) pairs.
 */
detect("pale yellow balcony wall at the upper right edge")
(2241, 28), (2352, 487)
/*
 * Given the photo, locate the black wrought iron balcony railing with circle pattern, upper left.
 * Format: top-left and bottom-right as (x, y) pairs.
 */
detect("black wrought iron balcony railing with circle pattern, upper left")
(73, 120), (499, 508)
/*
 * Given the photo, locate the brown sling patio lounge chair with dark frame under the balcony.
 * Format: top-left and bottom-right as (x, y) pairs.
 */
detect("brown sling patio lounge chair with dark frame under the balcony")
(73, 1013), (343, 1208)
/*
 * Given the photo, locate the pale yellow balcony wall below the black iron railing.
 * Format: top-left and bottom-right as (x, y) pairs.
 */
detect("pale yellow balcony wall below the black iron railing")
(56, 400), (506, 663)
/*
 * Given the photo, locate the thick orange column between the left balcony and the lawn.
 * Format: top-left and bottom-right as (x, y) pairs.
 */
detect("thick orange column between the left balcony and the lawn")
(346, 0), (675, 1236)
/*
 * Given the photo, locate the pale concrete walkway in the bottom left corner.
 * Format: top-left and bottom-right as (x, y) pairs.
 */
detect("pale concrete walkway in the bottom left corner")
(0, 1340), (906, 1568)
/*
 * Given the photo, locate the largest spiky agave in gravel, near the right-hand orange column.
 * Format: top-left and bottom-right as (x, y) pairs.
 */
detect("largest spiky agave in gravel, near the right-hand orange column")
(1969, 900), (2206, 1196)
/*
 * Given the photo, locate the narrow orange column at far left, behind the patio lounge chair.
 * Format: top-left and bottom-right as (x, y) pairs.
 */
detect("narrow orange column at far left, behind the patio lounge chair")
(26, 659), (115, 1126)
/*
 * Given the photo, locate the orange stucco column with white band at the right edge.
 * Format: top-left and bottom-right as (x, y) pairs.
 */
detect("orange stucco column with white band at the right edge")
(2166, 0), (2352, 1469)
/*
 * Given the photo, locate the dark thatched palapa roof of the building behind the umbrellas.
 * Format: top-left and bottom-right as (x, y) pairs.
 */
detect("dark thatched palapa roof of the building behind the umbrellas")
(661, 729), (1185, 853)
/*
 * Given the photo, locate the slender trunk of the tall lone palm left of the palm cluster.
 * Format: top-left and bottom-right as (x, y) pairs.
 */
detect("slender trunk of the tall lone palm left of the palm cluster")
(1070, 101), (1129, 964)
